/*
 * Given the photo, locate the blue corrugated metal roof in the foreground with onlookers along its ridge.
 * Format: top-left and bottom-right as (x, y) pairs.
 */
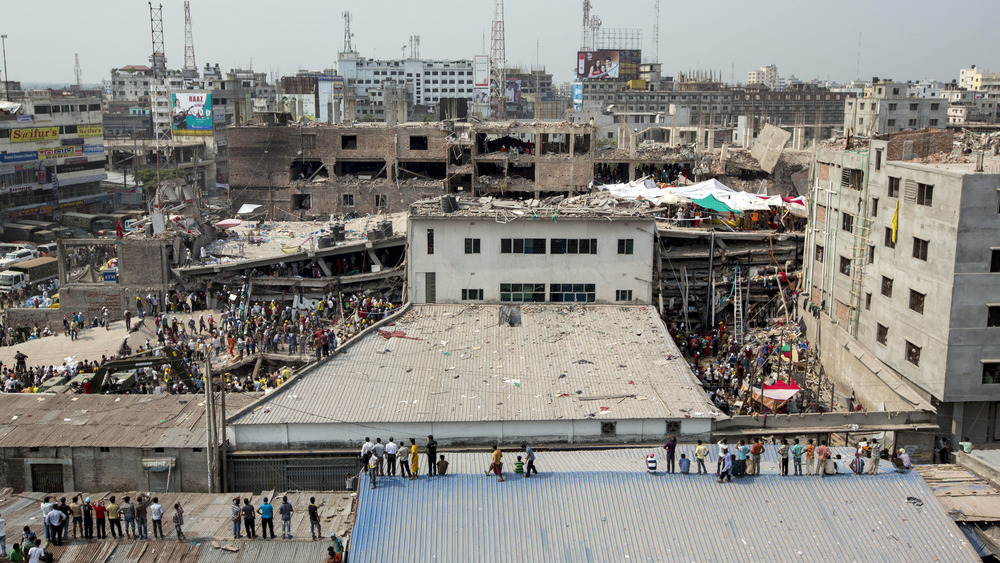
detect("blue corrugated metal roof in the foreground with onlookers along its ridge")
(350, 447), (979, 563)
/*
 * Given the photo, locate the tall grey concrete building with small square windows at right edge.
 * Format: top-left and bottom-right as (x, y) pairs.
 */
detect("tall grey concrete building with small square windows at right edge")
(805, 140), (1000, 450)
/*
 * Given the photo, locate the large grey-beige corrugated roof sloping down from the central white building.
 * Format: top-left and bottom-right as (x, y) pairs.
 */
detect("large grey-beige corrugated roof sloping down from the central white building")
(236, 305), (716, 425)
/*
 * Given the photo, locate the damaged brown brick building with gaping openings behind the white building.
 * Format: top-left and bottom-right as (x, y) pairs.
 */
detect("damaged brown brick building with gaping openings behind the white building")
(229, 122), (594, 220)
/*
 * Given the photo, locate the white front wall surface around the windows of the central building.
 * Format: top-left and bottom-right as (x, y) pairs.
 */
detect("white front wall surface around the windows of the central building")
(407, 212), (655, 304)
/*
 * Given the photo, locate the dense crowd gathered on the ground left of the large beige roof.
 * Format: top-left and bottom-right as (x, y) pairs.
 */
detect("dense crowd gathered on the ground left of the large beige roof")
(0, 288), (399, 394)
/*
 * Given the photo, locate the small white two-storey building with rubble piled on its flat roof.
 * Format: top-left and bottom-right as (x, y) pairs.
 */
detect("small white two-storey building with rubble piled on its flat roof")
(407, 198), (656, 304)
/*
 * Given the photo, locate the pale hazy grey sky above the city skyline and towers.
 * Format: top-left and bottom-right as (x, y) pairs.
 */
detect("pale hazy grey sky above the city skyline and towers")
(7, 0), (1000, 84)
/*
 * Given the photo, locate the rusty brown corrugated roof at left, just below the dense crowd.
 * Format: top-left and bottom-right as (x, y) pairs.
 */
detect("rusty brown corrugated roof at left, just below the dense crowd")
(0, 393), (260, 448)
